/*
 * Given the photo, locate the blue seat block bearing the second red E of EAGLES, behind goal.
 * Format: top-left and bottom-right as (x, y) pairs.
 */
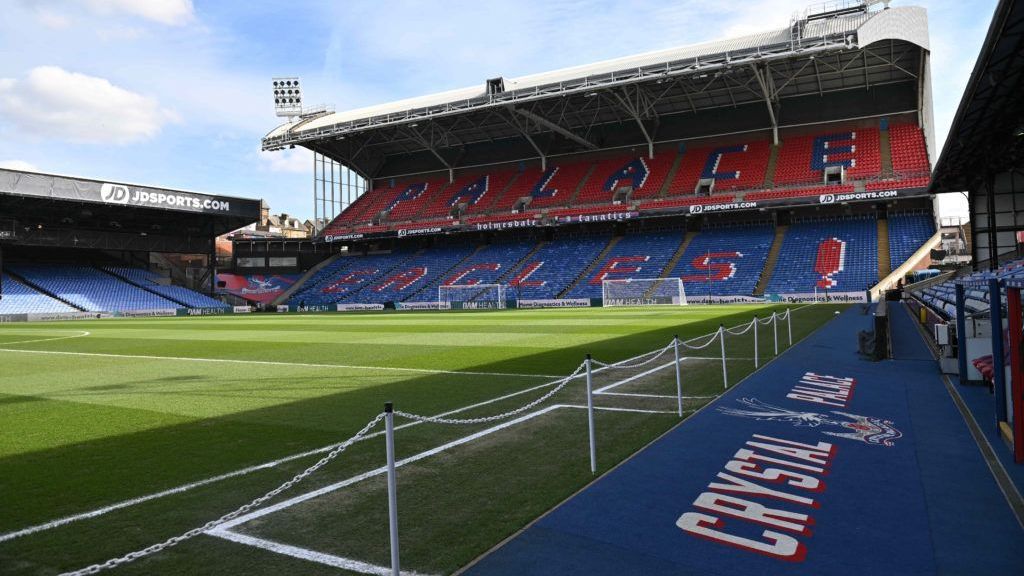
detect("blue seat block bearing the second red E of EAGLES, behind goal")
(567, 231), (683, 298)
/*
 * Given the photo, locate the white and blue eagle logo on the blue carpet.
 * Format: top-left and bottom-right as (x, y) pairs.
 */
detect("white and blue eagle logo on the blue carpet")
(718, 398), (903, 446)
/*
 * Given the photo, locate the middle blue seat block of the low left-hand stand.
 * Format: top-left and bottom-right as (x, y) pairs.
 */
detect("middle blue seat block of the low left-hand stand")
(8, 263), (180, 312)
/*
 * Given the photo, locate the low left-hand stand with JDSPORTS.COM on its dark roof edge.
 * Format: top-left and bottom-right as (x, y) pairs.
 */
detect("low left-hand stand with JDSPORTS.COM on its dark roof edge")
(0, 169), (260, 321)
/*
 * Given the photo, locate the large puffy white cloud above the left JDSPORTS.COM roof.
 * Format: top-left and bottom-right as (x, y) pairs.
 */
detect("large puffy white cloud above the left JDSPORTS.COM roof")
(0, 66), (177, 145)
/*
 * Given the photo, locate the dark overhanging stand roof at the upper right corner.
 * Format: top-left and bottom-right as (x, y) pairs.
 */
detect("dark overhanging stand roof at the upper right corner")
(931, 0), (1024, 194)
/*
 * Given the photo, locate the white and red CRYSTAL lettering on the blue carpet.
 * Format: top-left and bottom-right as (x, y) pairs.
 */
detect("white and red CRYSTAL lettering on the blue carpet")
(676, 434), (836, 562)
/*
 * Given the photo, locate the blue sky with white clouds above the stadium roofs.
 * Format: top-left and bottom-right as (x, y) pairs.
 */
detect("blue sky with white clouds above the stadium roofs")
(0, 0), (995, 218)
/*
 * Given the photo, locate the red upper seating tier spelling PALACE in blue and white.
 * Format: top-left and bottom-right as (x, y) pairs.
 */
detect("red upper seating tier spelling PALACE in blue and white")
(311, 119), (930, 235)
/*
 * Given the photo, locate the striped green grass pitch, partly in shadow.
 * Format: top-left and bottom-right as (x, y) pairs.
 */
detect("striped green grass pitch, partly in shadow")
(0, 305), (837, 574)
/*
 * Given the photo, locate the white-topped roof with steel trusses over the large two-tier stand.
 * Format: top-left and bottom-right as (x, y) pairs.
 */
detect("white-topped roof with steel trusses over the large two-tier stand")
(263, 2), (929, 177)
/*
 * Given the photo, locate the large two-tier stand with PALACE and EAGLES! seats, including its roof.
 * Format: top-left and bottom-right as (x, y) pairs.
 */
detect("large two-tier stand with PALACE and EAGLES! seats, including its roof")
(245, 2), (937, 307)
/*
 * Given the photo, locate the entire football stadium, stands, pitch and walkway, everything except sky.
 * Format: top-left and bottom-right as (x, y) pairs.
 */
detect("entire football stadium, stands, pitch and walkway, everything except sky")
(0, 0), (1024, 576)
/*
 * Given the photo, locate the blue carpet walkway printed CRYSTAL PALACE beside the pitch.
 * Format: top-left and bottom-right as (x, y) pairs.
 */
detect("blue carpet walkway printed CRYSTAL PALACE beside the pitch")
(467, 306), (1024, 576)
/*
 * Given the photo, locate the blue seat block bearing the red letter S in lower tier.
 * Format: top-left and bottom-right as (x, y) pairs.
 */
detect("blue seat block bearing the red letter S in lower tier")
(670, 224), (775, 297)
